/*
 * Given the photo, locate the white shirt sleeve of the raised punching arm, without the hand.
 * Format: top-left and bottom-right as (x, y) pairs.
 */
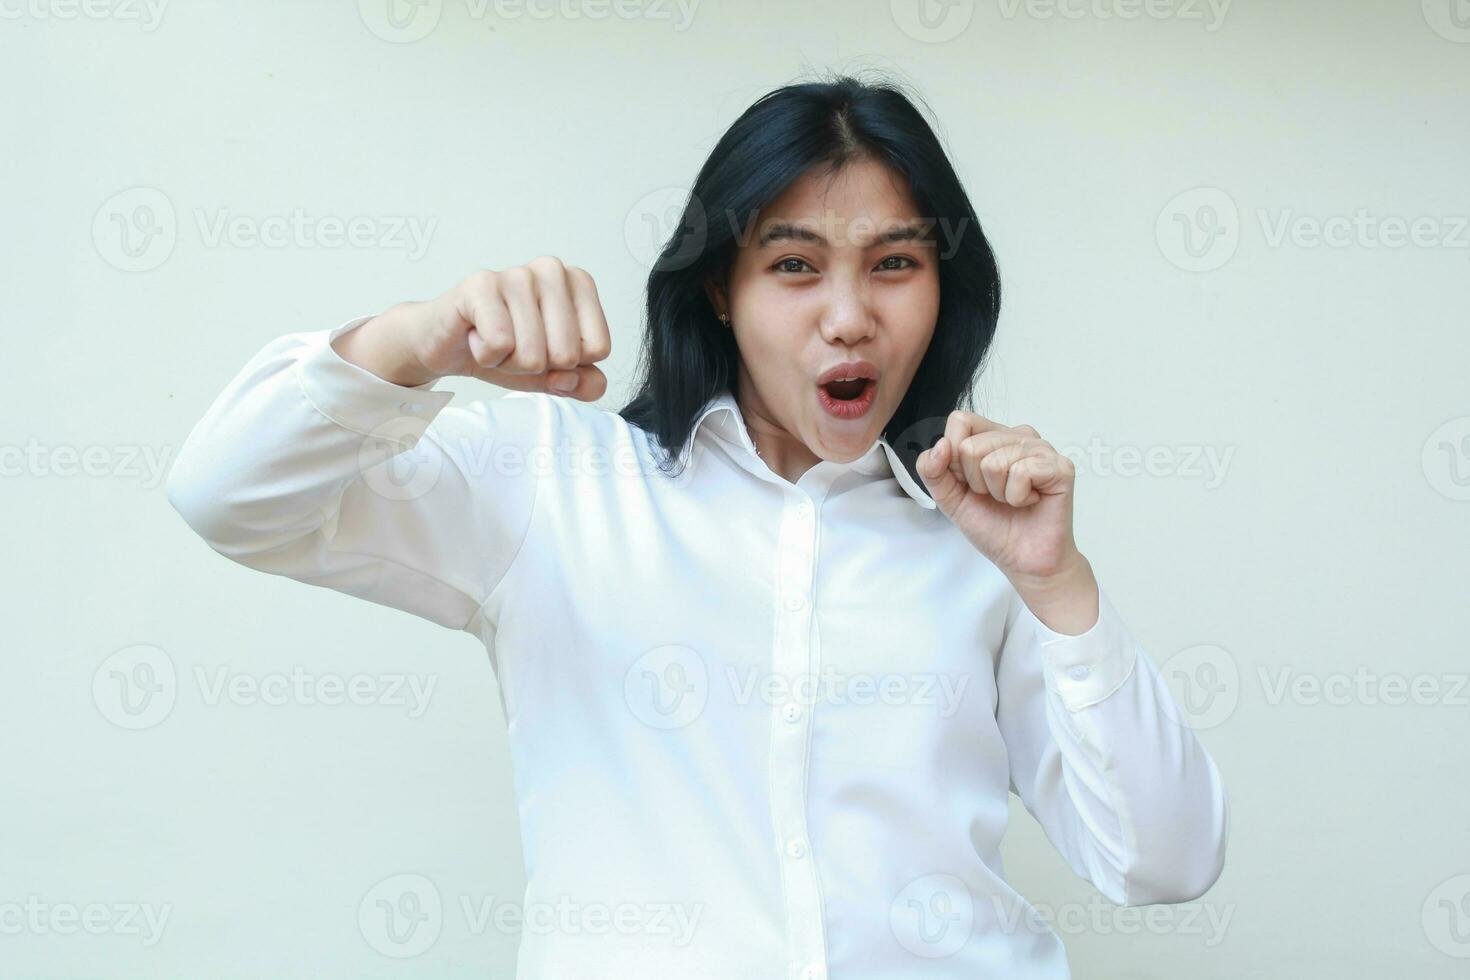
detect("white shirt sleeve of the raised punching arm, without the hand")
(166, 316), (554, 629)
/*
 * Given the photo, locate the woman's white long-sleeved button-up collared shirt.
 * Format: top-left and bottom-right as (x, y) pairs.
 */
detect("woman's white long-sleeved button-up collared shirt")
(168, 317), (1227, 980)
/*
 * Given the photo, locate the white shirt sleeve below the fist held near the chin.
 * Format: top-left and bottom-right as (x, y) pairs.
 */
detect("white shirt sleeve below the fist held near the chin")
(997, 578), (1229, 905)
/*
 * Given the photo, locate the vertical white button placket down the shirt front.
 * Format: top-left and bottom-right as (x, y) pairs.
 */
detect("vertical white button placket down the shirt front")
(770, 489), (826, 977)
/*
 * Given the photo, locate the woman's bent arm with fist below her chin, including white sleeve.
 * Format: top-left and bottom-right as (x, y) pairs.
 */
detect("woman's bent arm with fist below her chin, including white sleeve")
(919, 411), (1229, 905)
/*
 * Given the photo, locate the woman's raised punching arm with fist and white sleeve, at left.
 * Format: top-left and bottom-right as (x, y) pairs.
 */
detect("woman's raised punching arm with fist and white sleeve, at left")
(168, 257), (610, 629)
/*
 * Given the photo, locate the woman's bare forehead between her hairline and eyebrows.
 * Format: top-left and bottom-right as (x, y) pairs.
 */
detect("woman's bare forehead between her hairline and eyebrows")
(750, 160), (920, 247)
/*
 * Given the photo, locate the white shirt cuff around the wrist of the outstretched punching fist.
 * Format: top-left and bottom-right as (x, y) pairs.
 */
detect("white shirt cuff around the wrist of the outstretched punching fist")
(297, 313), (454, 450)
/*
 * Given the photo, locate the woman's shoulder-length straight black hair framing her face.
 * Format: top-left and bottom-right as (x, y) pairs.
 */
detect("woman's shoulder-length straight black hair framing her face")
(619, 75), (1001, 485)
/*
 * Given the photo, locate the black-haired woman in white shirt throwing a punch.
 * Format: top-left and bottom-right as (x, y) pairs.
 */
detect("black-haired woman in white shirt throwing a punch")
(168, 78), (1227, 980)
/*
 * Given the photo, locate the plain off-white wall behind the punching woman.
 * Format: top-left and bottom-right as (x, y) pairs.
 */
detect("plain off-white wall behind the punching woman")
(0, 0), (1470, 980)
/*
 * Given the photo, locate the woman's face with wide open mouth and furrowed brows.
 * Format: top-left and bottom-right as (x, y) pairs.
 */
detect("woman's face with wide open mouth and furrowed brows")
(711, 160), (939, 470)
